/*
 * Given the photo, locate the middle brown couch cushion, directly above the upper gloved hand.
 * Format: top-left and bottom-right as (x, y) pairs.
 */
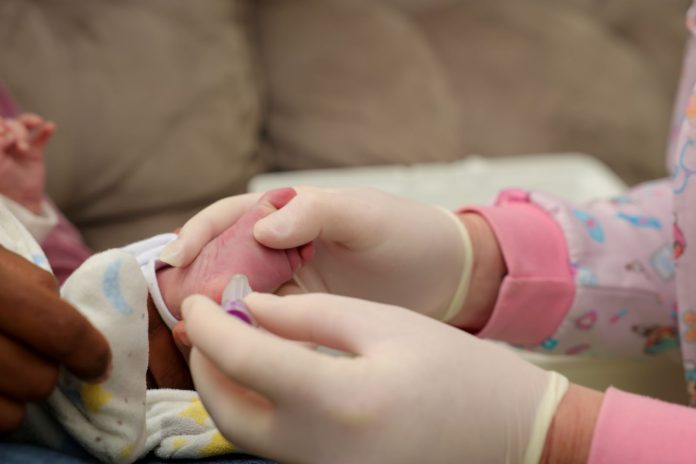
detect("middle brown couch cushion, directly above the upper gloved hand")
(257, 0), (461, 169)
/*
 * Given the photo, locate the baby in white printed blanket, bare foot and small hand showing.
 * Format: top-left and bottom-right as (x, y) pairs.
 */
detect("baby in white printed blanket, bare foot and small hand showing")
(0, 110), (310, 462)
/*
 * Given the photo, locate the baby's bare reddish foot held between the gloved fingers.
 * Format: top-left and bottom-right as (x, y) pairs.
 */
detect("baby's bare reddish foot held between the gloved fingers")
(158, 188), (310, 319)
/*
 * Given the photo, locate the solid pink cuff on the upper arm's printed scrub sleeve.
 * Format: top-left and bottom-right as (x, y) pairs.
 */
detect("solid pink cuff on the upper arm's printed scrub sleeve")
(460, 190), (575, 345)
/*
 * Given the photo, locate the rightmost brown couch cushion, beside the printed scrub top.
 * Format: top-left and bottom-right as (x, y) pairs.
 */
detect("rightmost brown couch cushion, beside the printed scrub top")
(410, 0), (690, 183)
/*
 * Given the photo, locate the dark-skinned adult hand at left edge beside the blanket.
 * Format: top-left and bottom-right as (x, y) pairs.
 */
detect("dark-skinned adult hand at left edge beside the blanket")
(0, 246), (111, 433)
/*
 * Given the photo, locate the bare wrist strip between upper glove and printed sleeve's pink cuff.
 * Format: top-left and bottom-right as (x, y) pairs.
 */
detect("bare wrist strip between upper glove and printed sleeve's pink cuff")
(449, 212), (507, 332)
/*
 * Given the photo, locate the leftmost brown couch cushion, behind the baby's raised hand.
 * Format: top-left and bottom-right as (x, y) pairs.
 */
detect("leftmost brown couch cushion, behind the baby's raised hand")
(0, 0), (260, 248)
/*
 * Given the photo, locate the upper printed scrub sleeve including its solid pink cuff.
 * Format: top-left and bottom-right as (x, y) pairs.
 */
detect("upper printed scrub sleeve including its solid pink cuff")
(464, 180), (679, 356)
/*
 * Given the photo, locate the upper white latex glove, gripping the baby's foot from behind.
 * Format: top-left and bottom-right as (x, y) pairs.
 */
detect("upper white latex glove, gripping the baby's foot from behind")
(161, 187), (473, 320)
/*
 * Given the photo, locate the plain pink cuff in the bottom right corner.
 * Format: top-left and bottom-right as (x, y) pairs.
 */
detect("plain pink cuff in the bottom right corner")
(588, 388), (696, 464)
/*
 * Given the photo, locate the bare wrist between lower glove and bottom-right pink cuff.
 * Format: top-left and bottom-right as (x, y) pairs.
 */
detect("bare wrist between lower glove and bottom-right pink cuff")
(540, 384), (604, 464)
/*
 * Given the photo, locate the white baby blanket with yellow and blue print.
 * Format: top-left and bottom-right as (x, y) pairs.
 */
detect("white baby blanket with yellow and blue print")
(0, 202), (235, 463)
